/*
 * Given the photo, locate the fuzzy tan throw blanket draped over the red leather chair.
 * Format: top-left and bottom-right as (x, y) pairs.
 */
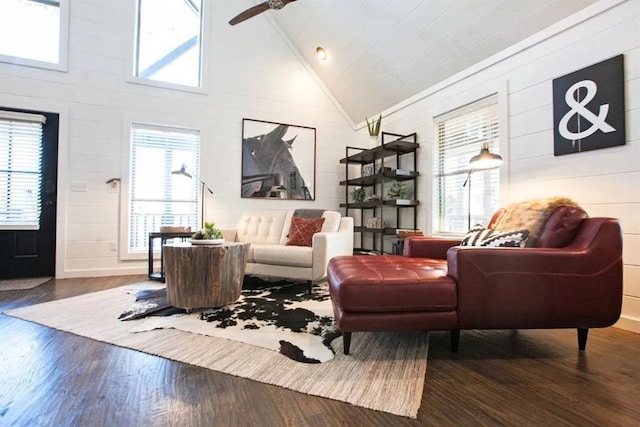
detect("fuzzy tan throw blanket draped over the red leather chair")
(493, 197), (580, 247)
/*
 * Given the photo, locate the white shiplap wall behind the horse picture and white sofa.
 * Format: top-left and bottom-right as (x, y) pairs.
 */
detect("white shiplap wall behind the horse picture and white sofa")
(0, 0), (354, 277)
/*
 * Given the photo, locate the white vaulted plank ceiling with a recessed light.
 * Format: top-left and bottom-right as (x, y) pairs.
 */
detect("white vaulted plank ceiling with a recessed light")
(238, 0), (597, 124)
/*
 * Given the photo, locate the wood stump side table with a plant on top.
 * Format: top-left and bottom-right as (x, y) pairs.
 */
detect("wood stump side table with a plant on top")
(163, 242), (249, 310)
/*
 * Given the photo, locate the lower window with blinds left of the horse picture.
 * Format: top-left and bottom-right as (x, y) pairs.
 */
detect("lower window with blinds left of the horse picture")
(127, 124), (200, 253)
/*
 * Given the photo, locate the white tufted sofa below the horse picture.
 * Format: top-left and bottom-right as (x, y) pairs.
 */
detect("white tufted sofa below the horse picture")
(221, 210), (353, 285)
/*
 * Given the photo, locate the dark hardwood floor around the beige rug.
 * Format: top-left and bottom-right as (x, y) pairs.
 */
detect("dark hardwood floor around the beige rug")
(0, 276), (640, 426)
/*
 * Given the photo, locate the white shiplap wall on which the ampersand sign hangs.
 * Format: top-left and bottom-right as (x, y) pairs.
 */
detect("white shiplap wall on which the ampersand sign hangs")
(368, 0), (640, 332)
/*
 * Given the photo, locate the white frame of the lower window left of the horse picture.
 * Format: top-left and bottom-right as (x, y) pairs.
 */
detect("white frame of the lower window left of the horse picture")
(119, 121), (202, 260)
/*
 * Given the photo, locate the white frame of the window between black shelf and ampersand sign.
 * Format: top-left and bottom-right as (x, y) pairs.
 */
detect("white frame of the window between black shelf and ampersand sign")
(431, 91), (508, 237)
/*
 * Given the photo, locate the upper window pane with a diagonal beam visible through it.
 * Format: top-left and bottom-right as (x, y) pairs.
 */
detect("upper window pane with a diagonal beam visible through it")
(134, 0), (202, 87)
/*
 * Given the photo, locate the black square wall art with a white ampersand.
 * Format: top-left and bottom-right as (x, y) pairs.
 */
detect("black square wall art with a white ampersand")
(553, 55), (625, 156)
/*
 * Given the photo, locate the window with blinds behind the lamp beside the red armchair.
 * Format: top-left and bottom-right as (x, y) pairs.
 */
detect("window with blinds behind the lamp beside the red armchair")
(433, 95), (500, 233)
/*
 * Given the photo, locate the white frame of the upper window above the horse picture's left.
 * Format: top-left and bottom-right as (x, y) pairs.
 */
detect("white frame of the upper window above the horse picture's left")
(126, 0), (211, 95)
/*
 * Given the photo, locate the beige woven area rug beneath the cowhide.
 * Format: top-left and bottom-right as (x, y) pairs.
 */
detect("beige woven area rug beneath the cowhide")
(5, 282), (429, 418)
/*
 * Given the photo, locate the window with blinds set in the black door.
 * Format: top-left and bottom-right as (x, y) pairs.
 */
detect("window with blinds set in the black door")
(0, 111), (46, 230)
